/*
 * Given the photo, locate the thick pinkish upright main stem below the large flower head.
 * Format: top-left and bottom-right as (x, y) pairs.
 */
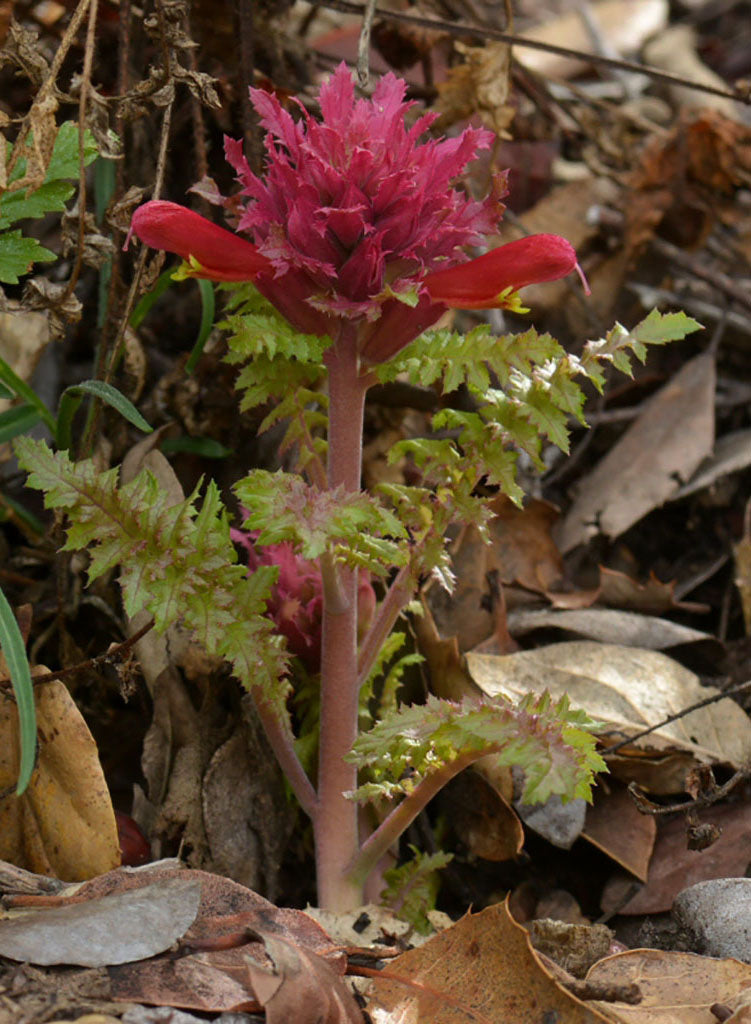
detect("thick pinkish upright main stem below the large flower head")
(314, 324), (367, 910)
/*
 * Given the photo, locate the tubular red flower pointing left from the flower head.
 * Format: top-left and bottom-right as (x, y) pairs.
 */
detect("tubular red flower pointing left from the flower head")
(130, 200), (270, 281)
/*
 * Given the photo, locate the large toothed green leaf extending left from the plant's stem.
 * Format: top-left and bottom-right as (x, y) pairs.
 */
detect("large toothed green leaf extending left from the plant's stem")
(15, 437), (287, 718)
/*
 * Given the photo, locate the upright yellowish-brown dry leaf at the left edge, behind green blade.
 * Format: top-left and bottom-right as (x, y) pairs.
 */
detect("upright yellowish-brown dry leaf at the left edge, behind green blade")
(0, 679), (120, 882)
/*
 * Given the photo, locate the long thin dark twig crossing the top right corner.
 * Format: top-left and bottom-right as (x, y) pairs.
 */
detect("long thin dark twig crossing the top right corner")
(320, 0), (751, 106)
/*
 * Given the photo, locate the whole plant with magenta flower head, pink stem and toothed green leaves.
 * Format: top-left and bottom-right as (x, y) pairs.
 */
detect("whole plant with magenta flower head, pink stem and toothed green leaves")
(17, 66), (697, 909)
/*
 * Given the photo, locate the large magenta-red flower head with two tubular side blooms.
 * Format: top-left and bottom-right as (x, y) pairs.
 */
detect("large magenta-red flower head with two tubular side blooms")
(131, 65), (588, 366)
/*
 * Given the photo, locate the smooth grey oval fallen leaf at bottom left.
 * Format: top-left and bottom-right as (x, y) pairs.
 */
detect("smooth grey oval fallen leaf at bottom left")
(0, 878), (201, 967)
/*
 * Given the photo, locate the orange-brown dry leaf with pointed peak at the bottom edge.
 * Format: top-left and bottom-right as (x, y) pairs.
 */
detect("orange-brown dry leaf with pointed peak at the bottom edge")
(367, 903), (608, 1024)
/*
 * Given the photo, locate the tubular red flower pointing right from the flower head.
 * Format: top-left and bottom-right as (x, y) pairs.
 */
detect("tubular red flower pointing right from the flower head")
(423, 234), (578, 309)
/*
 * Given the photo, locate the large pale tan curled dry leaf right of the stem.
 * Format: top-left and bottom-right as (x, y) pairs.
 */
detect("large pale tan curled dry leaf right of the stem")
(465, 640), (751, 766)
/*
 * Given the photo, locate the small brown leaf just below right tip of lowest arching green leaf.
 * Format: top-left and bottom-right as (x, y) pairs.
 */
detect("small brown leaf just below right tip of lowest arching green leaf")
(582, 782), (657, 882)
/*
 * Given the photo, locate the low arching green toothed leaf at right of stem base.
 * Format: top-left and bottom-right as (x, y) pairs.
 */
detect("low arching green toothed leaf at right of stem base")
(350, 693), (607, 804)
